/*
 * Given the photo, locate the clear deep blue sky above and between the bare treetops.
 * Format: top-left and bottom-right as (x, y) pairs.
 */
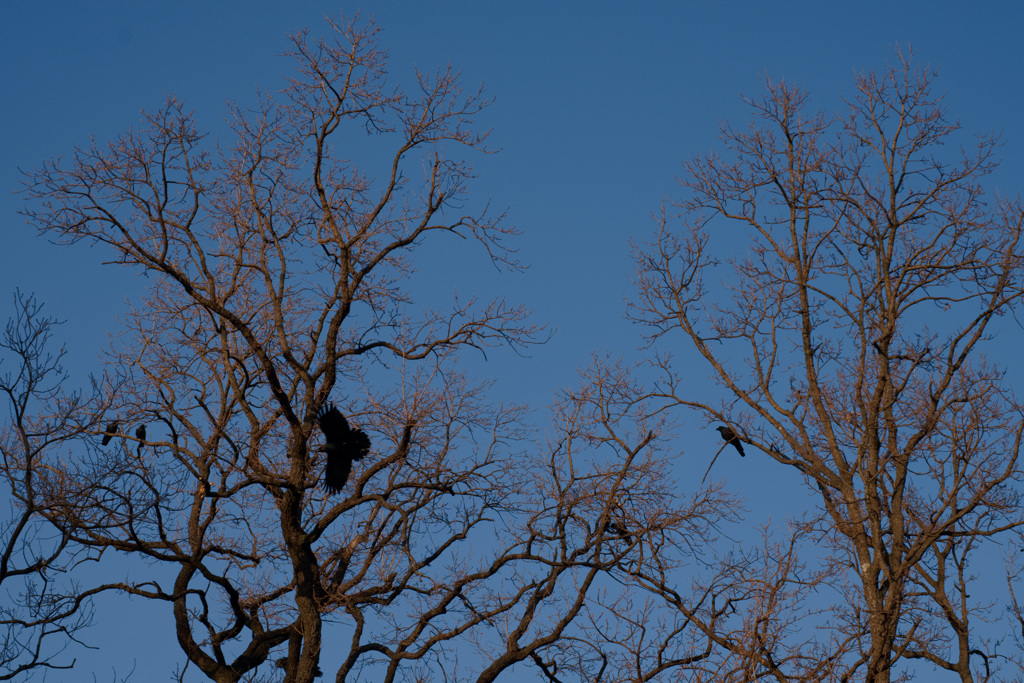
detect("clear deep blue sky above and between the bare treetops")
(0, 0), (1024, 680)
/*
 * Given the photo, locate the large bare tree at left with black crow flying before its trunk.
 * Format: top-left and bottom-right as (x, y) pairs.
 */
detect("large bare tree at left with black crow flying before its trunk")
(22, 15), (537, 681)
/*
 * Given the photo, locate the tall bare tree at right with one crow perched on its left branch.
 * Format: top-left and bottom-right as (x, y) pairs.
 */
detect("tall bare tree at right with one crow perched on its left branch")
(632, 50), (1024, 682)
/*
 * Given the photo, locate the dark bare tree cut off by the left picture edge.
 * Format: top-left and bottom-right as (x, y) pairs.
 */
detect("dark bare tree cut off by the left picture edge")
(0, 293), (91, 681)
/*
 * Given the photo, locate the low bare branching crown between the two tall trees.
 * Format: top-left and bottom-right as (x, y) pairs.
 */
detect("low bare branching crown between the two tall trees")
(480, 359), (746, 682)
